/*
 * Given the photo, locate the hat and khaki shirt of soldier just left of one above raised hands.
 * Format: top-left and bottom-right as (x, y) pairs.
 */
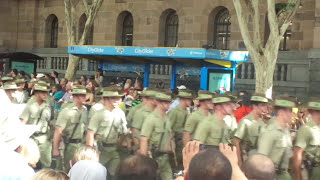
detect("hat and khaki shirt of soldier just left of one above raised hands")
(184, 90), (212, 139)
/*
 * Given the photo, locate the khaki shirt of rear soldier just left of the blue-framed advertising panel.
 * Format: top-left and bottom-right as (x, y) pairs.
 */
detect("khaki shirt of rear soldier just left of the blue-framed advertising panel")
(169, 105), (188, 134)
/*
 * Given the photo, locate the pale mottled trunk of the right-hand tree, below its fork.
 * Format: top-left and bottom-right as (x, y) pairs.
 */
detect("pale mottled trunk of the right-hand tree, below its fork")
(254, 55), (276, 98)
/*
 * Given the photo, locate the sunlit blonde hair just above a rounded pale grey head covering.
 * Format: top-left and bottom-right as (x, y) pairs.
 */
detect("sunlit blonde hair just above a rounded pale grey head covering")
(72, 145), (99, 164)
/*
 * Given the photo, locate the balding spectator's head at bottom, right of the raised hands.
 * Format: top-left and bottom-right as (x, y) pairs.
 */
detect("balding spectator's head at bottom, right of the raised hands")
(242, 154), (276, 180)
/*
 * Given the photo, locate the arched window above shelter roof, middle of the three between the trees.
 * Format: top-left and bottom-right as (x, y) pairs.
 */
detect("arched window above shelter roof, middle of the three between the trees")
(164, 11), (179, 47)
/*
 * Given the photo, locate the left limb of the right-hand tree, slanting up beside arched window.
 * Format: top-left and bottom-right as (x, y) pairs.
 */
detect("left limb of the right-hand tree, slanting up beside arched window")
(233, 0), (259, 58)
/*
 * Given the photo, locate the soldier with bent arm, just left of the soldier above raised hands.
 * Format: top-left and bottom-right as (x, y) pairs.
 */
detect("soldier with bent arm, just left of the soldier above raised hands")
(183, 90), (213, 146)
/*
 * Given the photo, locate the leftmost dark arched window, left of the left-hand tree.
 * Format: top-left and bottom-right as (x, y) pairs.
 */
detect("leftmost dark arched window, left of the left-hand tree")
(45, 14), (59, 48)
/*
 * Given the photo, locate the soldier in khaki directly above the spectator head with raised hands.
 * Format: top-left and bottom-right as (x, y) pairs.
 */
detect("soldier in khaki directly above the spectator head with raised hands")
(194, 95), (234, 146)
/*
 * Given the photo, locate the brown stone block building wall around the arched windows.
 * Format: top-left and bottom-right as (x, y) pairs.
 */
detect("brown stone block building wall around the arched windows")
(0, 0), (320, 50)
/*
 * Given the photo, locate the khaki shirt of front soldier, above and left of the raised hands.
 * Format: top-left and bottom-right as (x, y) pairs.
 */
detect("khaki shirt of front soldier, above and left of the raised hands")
(141, 110), (171, 150)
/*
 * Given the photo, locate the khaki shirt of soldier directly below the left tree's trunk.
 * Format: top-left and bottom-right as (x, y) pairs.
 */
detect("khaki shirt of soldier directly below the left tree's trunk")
(56, 103), (87, 139)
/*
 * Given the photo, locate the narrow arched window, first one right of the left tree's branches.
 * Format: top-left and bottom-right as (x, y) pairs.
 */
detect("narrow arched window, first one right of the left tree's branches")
(122, 12), (133, 46)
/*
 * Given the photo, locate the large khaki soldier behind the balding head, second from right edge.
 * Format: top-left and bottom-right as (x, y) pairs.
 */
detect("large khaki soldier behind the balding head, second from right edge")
(258, 97), (297, 180)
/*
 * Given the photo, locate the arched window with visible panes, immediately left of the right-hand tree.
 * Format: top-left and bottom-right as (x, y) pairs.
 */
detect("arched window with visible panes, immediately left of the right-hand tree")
(213, 8), (231, 49)
